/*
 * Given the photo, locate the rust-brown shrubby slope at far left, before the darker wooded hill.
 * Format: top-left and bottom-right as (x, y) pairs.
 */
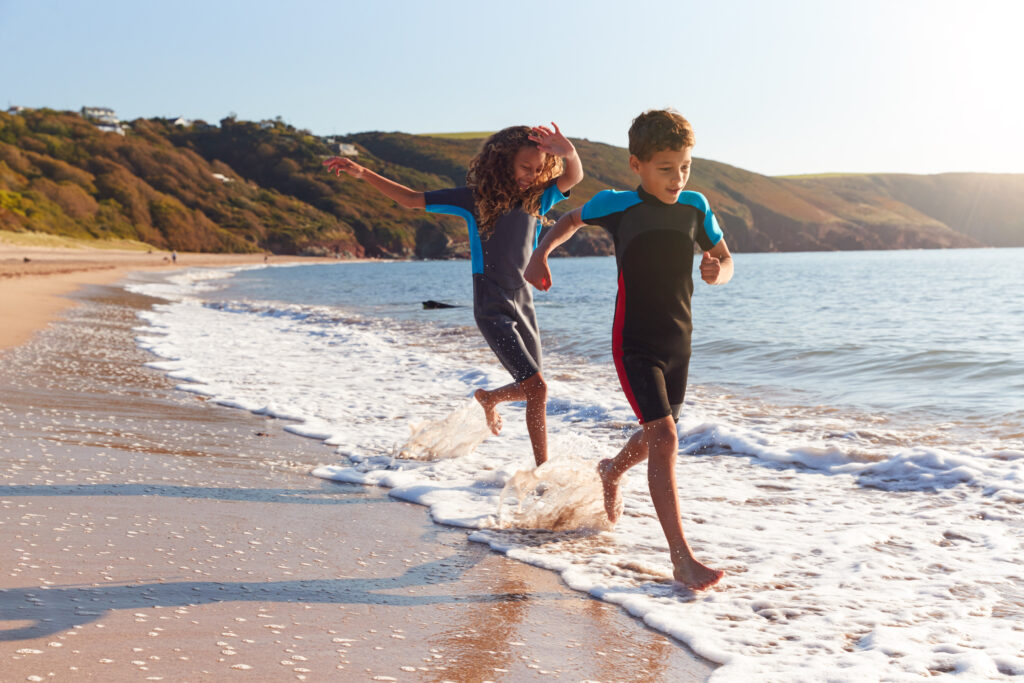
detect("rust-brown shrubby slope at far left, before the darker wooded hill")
(0, 110), (358, 252)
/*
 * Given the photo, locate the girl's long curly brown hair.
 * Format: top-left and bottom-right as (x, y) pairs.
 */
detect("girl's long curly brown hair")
(466, 126), (562, 240)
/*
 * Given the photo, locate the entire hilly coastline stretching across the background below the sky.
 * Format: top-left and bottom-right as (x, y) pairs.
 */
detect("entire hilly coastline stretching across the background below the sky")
(0, 110), (1024, 258)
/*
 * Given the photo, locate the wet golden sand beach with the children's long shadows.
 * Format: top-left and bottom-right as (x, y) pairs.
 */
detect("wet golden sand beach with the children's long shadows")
(0, 244), (714, 681)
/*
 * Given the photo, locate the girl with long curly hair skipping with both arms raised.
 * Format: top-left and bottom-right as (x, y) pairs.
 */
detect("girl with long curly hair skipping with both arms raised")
(324, 123), (583, 466)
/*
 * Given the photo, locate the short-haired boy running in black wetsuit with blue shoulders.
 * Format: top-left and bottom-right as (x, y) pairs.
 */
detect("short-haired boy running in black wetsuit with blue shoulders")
(524, 110), (733, 590)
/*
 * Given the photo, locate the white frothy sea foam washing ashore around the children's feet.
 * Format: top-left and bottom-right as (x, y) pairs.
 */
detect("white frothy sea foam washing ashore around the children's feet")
(128, 264), (1024, 681)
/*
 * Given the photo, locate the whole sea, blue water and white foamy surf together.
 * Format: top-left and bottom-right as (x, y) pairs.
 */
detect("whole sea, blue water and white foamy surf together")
(129, 249), (1024, 681)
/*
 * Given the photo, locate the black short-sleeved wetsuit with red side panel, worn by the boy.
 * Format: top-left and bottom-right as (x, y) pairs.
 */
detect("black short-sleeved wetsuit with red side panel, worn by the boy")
(582, 187), (723, 424)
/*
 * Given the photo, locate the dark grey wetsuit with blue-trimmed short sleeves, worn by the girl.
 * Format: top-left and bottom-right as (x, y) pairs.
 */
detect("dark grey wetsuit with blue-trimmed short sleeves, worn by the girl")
(424, 181), (567, 382)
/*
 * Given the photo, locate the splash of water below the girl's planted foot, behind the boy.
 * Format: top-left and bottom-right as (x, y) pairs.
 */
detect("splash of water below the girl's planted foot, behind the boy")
(498, 455), (612, 531)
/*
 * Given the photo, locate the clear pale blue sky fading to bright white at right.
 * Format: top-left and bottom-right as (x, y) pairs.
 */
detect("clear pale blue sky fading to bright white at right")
(0, 0), (1024, 175)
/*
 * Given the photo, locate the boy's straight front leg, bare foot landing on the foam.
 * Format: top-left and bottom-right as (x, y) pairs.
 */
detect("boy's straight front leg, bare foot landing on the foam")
(643, 416), (723, 591)
